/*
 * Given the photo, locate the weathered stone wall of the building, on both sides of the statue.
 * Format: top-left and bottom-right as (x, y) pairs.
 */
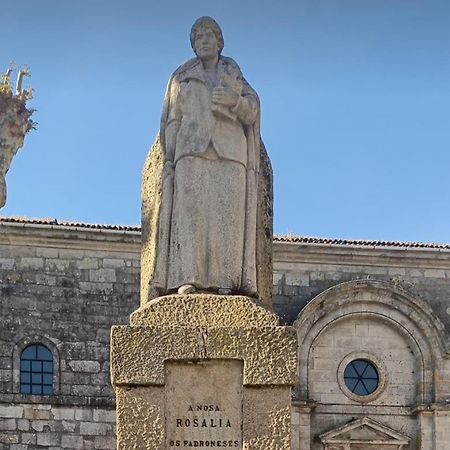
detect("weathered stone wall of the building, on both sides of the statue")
(0, 220), (450, 450)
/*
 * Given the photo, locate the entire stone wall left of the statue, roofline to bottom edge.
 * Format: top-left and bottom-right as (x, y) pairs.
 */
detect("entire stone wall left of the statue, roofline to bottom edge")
(0, 224), (140, 450)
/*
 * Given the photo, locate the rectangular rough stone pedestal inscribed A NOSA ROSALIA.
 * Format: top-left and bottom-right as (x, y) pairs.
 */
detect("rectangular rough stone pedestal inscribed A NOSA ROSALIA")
(111, 314), (297, 450)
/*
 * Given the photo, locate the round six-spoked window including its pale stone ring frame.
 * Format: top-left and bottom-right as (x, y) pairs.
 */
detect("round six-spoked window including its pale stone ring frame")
(337, 352), (388, 403)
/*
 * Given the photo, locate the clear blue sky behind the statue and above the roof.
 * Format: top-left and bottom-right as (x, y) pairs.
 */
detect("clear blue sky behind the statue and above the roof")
(0, 0), (450, 242)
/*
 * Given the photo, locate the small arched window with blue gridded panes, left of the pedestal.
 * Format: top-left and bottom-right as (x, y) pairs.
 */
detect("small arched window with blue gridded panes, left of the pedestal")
(20, 344), (53, 395)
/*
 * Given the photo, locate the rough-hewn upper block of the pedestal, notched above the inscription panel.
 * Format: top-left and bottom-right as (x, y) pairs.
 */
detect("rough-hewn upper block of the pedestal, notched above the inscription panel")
(111, 326), (296, 386)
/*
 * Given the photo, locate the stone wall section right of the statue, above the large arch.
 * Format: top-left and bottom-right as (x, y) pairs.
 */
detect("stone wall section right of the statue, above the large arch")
(273, 239), (450, 329)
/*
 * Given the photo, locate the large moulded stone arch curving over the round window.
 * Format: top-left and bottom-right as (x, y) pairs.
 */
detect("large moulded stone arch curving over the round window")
(294, 280), (447, 403)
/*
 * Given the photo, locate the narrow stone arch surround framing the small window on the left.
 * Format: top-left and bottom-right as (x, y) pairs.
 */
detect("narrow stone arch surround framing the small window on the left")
(12, 334), (61, 395)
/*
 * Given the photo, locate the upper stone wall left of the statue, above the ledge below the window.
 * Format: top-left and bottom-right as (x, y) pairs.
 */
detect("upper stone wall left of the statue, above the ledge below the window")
(0, 222), (139, 398)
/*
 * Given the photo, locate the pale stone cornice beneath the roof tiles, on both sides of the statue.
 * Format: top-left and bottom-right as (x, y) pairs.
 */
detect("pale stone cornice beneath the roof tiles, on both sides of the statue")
(0, 221), (450, 270)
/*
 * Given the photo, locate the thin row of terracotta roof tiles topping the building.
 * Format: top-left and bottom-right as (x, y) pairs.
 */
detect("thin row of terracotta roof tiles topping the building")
(0, 216), (450, 250)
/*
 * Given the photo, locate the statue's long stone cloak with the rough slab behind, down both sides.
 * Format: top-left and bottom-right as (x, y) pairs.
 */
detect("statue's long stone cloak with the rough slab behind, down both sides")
(141, 56), (272, 304)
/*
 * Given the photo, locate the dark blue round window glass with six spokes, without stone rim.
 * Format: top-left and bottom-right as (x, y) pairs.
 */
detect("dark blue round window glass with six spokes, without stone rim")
(344, 359), (380, 395)
